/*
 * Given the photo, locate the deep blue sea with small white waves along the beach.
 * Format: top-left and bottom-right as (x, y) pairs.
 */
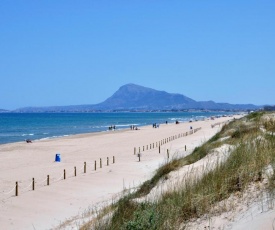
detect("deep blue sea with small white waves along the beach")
(0, 112), (237, 144)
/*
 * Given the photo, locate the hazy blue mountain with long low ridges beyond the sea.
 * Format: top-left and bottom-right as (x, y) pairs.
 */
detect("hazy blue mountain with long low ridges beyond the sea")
(14, 84), (260, 112)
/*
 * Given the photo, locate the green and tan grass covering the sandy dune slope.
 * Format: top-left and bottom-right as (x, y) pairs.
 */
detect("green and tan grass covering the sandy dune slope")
(83, 112), (275, 230)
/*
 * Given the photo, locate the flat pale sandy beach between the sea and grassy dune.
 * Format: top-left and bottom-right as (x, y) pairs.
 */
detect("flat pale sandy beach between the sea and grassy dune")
(0, 116), (239, 230)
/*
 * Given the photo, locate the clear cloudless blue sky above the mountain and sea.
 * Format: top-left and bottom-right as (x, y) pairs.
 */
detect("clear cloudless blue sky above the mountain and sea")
(0, 0), (275, 109)
